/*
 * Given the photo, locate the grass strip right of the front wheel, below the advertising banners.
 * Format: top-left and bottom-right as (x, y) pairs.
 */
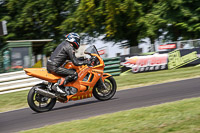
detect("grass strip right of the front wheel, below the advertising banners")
(115, 67), (200, 89)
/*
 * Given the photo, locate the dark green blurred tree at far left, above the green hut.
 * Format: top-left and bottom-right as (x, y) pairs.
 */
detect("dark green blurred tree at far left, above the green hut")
(3, 0), (77, 40)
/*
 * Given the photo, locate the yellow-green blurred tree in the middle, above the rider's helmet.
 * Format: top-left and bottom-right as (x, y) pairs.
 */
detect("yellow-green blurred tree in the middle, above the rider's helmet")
(60, 0), (142, 46)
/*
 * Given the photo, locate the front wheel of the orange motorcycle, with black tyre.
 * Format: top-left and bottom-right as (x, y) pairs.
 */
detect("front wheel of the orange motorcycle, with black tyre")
(93, 77), (117, 101)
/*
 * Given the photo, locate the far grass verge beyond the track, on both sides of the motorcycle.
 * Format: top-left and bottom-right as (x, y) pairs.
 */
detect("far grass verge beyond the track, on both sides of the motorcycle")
(0, 67), (200, 112)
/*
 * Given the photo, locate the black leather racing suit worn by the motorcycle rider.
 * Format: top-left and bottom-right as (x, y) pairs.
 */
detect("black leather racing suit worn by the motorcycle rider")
(47, 41), (87, 81)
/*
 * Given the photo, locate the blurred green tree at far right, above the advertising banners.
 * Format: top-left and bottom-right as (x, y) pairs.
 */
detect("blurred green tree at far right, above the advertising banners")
(131, 0), (200, 44)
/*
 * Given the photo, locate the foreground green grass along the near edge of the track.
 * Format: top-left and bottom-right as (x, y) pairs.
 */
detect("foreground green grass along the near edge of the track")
(19, 98), (200, 133)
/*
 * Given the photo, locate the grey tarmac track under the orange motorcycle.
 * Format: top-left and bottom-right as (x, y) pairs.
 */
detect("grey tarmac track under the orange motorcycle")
(0, 78), (200, 133)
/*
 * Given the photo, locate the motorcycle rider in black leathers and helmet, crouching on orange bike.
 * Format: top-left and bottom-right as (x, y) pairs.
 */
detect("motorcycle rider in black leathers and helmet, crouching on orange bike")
(47, 33), (90, 94)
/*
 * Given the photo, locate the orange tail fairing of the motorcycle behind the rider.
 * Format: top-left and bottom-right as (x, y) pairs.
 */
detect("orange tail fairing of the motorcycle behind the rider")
(24, 68), (61, 82)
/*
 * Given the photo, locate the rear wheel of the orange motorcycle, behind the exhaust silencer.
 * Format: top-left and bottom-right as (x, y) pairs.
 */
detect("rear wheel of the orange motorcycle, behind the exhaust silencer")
(27, 84), (56, 112)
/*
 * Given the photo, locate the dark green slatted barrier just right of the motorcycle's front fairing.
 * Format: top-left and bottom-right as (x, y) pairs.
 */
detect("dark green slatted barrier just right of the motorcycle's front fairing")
(103, 57), (121, 76)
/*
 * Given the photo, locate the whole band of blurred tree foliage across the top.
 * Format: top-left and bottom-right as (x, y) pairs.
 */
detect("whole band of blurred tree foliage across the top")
(0, 0), (200, 47)
